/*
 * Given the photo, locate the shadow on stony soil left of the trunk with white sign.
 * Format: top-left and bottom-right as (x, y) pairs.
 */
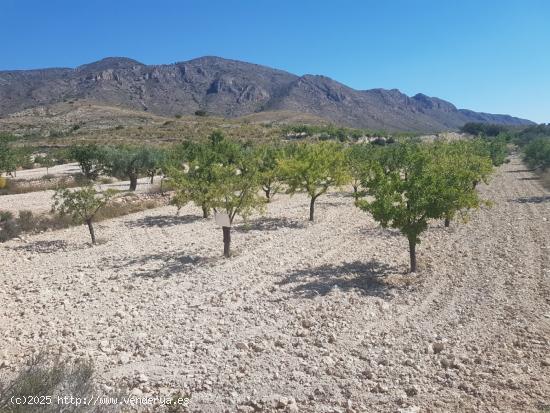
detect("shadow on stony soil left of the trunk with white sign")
(111, 254), (217, 278)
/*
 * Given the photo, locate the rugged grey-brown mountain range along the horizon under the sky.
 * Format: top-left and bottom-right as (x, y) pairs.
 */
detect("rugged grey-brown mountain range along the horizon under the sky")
(0, 56), (533, 132)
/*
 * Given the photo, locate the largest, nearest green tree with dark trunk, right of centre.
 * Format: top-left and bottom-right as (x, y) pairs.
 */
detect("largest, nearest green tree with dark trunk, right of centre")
(356, 143), (494, 272)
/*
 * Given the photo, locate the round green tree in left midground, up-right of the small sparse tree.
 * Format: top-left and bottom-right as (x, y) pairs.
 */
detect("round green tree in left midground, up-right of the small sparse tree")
(105, 145), (161, 191)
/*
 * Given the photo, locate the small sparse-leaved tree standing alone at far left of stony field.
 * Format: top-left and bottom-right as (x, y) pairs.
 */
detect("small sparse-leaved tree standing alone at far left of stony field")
(52, 185), (115, 244)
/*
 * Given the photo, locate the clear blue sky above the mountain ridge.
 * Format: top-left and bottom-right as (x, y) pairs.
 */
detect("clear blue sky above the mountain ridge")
(0, 0), (550, 122)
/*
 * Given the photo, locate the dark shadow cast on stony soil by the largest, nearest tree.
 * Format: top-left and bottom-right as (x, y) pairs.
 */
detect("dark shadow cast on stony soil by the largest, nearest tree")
(278, 261), (399, 298)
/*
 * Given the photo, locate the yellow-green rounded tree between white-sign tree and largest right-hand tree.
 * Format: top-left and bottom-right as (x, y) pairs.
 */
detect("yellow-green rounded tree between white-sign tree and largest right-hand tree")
(279, 141), (349, 221)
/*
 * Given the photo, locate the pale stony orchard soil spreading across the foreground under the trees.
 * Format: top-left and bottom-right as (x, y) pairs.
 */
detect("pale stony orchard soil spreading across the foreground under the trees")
(0, 156), (550, 413)
